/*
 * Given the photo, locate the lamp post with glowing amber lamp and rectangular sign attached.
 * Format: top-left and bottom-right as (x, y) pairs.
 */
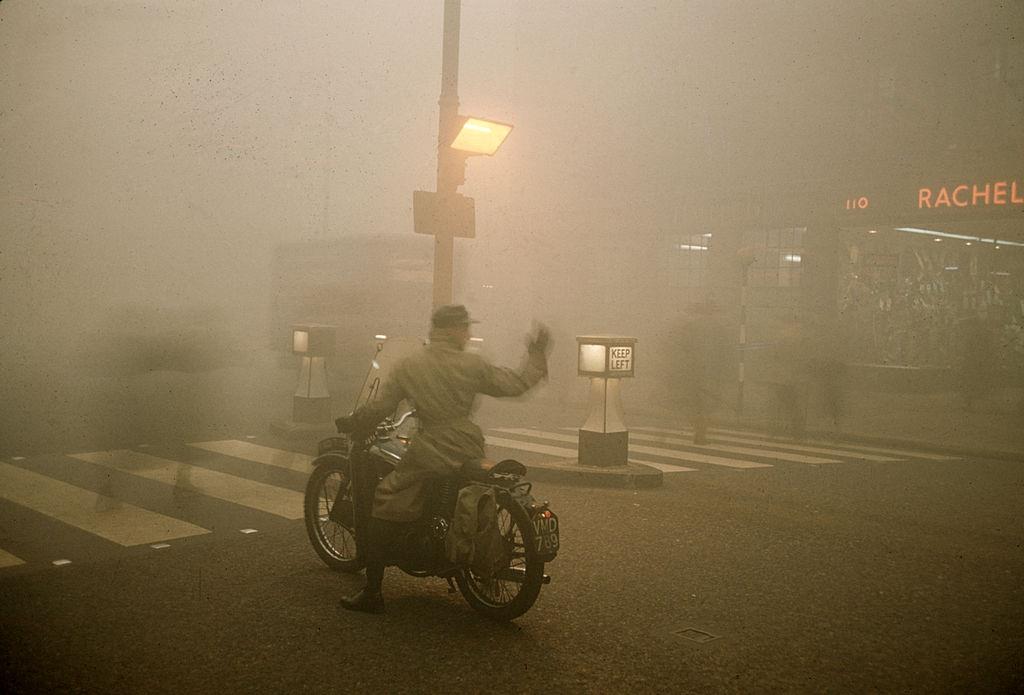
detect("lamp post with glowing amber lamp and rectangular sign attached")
(413, 0), (512, 307)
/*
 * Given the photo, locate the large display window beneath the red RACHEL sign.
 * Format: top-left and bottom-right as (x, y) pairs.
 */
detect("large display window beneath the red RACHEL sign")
(839, 233), (1024, 374)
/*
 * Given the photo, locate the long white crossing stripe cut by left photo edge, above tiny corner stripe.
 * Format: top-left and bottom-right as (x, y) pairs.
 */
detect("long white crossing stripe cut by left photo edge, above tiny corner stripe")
(0, 464), (209, 546)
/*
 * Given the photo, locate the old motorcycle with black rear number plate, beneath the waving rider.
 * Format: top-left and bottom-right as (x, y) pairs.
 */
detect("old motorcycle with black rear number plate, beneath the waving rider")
(304, 411), (559, 620)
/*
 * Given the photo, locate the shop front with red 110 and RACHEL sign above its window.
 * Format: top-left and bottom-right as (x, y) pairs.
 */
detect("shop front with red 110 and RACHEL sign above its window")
(836, 172), (1024, 387)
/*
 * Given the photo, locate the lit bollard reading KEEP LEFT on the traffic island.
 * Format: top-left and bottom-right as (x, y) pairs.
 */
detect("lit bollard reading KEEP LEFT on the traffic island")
(577, 336), (637, 467)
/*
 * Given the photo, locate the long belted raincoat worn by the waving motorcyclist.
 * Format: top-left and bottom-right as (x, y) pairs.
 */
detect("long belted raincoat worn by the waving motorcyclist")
(354, 336), (548, 521)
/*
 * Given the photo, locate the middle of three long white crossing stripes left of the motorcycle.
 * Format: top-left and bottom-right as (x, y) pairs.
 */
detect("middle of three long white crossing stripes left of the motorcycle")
(73, 449), (302, 519)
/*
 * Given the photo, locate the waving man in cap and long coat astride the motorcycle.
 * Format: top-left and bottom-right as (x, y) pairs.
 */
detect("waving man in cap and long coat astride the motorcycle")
(336, 305), (550, 613)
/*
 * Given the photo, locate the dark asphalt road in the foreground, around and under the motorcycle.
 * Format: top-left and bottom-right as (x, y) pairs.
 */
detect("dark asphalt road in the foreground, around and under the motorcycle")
(0, 448), (1024, 693)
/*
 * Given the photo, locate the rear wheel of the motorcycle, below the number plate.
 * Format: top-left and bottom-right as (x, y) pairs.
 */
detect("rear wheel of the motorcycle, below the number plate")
(455, 497), (544, 620)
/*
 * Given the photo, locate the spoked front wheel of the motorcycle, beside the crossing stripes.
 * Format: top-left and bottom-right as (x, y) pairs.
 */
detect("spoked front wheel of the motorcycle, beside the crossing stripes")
(303, 455), (362, 572)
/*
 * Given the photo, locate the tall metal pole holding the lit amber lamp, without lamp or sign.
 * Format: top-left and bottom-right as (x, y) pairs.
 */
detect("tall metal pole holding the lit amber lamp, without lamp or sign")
(433, 0), (462, 308)
